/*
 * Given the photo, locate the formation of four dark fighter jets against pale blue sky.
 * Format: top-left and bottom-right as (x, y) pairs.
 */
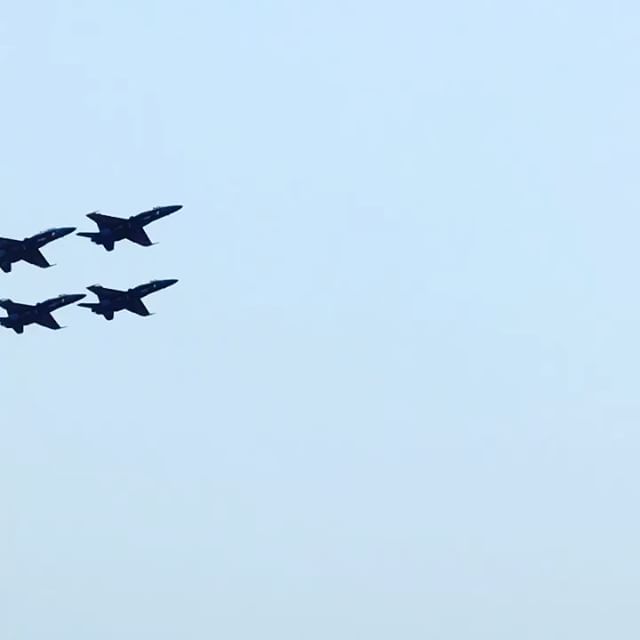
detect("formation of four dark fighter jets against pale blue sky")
(0, 205), (182, 333)
